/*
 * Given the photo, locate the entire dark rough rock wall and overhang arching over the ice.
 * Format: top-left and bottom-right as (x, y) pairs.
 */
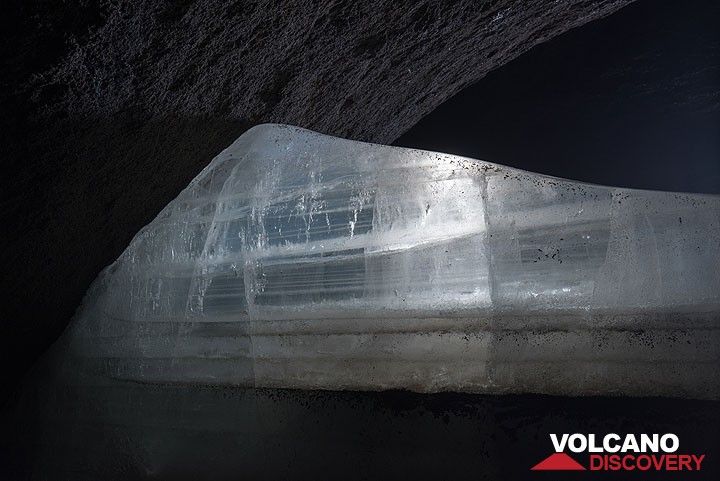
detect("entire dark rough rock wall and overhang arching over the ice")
(0, 0), (630, 394)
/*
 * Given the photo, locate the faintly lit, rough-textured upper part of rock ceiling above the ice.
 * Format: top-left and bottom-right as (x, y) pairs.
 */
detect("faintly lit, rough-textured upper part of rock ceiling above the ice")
(23, 0), (628, 143)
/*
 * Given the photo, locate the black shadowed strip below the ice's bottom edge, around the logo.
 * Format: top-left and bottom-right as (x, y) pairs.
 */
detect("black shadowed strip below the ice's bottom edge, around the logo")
(1, 368), (720, 481)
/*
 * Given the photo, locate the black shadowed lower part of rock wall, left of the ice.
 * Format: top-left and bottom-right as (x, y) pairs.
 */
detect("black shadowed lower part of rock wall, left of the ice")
(0, 112), (249, 399)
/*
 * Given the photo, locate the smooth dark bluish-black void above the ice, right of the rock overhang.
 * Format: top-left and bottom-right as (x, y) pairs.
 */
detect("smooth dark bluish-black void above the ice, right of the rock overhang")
(395, 0), (720, 194)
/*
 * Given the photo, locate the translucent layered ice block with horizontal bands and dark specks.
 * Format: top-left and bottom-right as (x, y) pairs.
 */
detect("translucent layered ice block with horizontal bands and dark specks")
(59, 125), (720, 397)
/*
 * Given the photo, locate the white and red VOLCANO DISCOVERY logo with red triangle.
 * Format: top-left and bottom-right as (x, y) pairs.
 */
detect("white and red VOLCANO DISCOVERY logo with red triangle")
(531, 433), (705, 471)
